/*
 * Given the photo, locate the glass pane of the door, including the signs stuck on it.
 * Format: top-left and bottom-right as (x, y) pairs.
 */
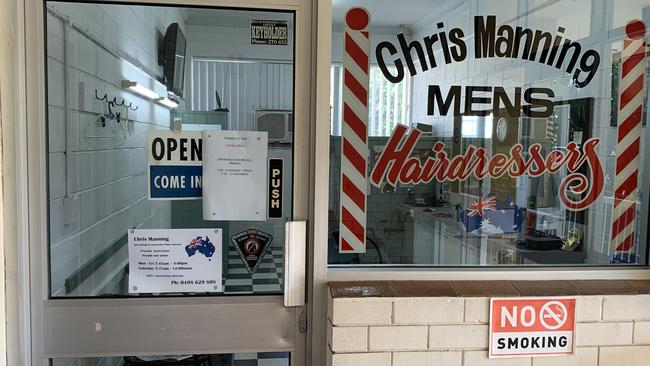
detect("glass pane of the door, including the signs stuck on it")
(46, 1), (294, 297)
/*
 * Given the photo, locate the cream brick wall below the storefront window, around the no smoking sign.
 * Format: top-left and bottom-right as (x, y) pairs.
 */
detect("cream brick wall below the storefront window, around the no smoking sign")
(328, 284), (650, 366)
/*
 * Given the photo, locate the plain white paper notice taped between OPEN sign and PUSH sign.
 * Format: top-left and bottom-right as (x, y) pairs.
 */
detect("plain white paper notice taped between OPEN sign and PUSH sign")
(203, 131), (268, 221)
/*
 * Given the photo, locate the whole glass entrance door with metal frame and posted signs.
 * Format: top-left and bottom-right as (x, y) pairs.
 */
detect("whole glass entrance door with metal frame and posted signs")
(24, 0), (310, 365)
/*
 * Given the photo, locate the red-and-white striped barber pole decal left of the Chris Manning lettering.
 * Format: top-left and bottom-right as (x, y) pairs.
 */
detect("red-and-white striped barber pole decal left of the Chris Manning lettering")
(339, 8), (370, 253)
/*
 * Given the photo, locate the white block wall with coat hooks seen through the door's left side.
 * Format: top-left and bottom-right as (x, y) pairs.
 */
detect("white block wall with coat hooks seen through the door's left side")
(47, 3), (183, 296)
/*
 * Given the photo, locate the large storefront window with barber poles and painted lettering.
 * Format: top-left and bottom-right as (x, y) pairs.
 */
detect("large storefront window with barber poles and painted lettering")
(328, 0), (650, 267)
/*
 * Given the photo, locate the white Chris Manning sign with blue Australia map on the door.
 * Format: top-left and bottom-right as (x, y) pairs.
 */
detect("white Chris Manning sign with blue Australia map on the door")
(129, 229), (223, 293)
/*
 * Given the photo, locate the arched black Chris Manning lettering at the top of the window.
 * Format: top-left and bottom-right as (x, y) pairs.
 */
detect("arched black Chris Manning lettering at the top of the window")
(375, 15), (600, 88)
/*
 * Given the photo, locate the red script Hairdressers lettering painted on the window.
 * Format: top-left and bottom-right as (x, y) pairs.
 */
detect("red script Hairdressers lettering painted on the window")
(370, 125), (605, 210)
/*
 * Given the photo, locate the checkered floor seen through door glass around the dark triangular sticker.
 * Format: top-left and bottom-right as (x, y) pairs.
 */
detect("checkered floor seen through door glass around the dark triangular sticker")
(224, 245), (284, 294)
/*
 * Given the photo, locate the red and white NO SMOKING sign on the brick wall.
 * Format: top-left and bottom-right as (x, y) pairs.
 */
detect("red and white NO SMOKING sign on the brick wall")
(489, 297), (576, 358)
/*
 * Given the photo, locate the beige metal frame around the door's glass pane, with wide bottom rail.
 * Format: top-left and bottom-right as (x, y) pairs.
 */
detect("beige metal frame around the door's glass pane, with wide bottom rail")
(16, 0), (314, 365)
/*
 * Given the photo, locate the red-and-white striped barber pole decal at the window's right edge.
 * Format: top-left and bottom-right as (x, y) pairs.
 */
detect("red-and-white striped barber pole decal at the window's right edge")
(611, 20), (646, 262)
